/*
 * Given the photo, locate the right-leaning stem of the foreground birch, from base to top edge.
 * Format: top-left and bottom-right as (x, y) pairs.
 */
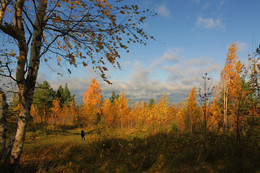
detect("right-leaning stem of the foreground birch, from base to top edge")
(10, 0), (47, 168)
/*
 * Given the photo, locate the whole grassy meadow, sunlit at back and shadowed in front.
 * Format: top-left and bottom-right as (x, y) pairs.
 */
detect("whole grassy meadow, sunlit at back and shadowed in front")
(20, 125), (260, 173)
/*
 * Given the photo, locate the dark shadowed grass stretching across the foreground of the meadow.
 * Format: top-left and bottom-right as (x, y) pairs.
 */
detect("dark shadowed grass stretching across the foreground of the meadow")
(22, 131), (260, 172)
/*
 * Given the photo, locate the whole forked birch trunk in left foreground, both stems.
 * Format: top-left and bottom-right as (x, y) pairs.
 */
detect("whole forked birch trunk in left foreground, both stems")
(0, 0), (47, 172)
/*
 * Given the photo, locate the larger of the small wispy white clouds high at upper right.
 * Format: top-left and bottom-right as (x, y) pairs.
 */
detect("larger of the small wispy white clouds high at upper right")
(195, 16), (224, 29)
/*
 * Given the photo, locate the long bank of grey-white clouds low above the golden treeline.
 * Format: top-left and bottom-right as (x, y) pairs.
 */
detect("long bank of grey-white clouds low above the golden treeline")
(40, 48), (221, 103)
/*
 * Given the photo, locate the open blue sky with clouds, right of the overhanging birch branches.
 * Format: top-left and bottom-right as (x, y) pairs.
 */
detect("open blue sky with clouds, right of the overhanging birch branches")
(33, 0), (260, 102)
